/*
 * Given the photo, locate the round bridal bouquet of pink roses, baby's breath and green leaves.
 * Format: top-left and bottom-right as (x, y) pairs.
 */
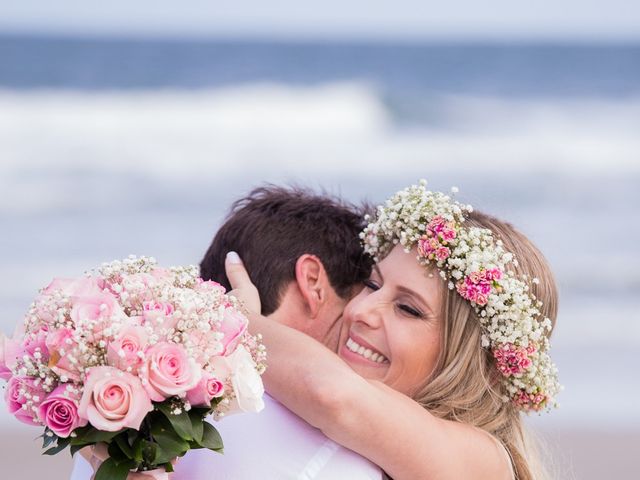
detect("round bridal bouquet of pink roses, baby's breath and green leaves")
(0, 257), (266, 480)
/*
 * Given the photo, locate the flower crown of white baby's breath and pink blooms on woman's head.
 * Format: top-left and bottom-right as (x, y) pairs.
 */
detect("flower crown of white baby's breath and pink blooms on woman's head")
(360, 180), (561, 411)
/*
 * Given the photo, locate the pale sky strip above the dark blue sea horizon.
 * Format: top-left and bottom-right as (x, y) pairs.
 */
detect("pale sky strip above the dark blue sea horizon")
(0, 0), (640, 41)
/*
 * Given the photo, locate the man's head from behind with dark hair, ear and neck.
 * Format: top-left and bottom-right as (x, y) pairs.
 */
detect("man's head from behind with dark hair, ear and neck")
(200, 186), (371, 340)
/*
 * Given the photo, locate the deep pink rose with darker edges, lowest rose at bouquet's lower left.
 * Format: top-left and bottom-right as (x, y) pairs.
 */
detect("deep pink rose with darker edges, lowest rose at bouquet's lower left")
(39, 385), (87, 438)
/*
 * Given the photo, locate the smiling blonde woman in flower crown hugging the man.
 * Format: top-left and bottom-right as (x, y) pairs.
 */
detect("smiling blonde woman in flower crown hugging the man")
(227, 182), (560, 480)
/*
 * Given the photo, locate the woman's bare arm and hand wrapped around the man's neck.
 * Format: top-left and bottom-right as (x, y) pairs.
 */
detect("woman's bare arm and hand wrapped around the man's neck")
(227, 255), (511, 480)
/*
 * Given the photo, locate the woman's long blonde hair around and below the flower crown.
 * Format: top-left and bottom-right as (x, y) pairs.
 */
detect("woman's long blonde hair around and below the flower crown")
(414, 212), (558, 480)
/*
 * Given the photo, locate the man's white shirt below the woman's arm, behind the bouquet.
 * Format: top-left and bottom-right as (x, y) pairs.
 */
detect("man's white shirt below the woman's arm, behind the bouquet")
(71, 394), (383, 480)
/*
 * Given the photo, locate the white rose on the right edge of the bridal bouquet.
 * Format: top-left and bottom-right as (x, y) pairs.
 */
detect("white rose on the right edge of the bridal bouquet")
(227, 345), (264, 413)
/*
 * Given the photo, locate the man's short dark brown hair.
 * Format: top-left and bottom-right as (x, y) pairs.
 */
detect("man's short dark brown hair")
(200, 185), (372, 315)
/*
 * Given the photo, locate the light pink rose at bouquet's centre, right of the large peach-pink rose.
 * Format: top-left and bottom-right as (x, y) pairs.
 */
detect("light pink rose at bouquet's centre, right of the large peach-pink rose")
(139, 342), (201, 402)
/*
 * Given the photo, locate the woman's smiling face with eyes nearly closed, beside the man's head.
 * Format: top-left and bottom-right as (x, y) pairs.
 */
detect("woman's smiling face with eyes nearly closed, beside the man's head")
(338, 246), (445, 396)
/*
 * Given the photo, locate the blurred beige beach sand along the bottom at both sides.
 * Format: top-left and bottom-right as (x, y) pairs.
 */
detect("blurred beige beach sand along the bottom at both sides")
(0, 429), (640, 480)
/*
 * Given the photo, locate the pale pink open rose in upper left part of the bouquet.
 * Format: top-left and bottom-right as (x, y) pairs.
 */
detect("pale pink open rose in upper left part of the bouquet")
(71, 292), (126, 336)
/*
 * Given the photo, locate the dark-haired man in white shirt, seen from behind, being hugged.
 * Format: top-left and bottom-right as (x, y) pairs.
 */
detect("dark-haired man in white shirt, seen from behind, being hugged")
(72, 186), (382, 480)
